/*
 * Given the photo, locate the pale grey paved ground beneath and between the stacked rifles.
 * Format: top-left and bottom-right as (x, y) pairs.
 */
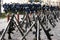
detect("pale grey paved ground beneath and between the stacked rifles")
(0, 15), (60, 40)
